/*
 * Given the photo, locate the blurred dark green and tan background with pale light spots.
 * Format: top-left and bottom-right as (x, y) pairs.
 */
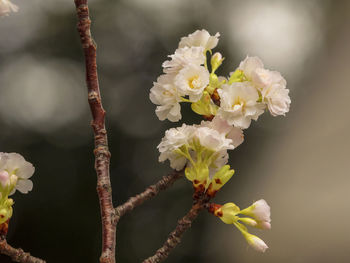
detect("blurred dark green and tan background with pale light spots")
(0, 0), (350, 263)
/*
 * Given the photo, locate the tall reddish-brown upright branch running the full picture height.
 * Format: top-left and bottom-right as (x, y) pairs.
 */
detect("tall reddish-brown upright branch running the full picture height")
(74, 0), (116, 263)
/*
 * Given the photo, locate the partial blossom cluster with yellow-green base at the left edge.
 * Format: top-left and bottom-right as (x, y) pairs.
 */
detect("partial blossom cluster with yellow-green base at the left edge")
(0, 152), (34, 224)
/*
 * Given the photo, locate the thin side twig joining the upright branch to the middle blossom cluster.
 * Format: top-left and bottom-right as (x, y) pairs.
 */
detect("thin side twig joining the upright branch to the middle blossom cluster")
(115, 170), (183, 223)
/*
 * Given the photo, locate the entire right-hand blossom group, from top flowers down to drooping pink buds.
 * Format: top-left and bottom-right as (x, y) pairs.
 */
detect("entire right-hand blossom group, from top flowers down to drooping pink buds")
(150, 30), (291, 252)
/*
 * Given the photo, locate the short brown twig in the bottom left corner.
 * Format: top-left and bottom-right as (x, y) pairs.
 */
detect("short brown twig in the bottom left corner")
(0, 238), (46, 263)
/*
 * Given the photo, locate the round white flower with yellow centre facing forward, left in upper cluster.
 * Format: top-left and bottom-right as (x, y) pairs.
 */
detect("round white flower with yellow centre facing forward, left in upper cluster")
(175, 65), (209, 102)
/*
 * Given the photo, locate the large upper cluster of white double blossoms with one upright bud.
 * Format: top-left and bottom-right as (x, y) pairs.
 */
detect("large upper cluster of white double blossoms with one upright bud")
(150, 30), (291, 129)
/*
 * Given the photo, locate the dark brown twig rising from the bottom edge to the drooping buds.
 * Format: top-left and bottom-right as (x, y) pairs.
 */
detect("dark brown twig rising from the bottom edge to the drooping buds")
(143, 194), (210, 263)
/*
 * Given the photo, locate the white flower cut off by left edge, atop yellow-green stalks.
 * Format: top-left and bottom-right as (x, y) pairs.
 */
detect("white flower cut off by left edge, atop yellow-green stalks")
(0, 153), (34, 194)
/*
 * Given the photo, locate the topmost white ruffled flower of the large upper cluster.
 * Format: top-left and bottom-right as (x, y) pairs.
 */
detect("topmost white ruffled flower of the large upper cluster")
(179, 29), (220, 50)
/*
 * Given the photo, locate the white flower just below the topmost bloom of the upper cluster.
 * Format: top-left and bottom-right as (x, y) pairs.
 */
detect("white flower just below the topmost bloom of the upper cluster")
(162, 47), (206, 74)
